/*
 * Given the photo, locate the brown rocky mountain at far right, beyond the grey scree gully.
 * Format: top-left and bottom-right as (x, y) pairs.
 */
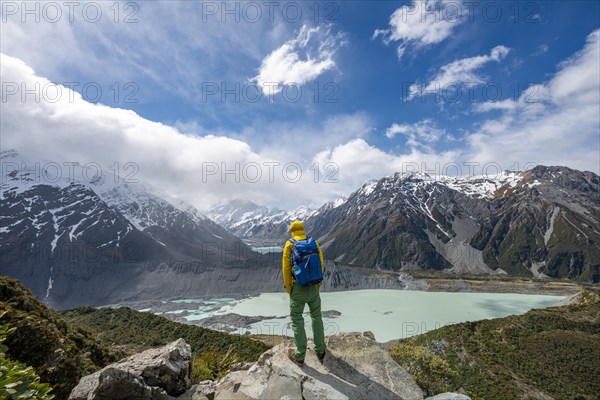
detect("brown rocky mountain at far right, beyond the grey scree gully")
(472, 166), (600, 282)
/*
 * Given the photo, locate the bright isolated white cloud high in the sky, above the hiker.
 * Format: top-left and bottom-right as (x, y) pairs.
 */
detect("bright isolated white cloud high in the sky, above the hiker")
(251, 25), (342, 95)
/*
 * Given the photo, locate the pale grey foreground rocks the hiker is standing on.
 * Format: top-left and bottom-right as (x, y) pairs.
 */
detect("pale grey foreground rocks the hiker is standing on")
(69, 332), (470, 400)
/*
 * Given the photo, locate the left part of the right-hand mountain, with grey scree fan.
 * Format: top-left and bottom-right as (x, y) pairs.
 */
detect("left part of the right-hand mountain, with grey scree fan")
(307, 173), (514, 272)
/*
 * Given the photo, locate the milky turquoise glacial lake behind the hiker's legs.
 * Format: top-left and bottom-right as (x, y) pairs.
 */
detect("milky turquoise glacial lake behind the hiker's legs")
(148, 289), (565, 342)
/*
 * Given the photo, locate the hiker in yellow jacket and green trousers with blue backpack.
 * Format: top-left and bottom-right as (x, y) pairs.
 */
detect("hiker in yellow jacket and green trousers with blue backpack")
(282, 221), (325, 367)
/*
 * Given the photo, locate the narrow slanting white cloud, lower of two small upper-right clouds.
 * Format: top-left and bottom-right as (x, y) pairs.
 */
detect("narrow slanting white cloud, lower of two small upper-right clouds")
(408, 46), (510, 100)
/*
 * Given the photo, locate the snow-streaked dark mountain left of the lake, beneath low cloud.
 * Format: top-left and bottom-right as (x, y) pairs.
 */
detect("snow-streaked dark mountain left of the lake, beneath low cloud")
(0, 151), (251, 304)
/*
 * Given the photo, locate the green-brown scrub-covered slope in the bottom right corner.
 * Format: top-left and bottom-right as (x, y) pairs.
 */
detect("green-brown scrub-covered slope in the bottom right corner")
(389, 290), (600, 400)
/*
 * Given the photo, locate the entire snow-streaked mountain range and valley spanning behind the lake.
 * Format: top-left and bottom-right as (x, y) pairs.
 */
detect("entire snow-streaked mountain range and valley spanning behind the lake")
(0, 150), (600, 308)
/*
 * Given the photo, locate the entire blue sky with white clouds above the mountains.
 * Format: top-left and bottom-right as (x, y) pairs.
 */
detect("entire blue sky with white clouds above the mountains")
(0, 0), (600, 207)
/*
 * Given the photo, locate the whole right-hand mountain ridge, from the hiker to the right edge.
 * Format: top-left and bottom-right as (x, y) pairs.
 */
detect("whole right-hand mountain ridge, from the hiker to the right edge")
(211, 166), (600, 282)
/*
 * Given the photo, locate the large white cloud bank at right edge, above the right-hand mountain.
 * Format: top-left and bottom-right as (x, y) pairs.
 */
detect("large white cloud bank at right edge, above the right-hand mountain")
(465, 30), (600, 173)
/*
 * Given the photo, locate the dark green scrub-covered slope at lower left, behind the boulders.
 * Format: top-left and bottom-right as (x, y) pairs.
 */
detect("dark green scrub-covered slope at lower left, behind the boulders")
(0, 276), (269, 400)
